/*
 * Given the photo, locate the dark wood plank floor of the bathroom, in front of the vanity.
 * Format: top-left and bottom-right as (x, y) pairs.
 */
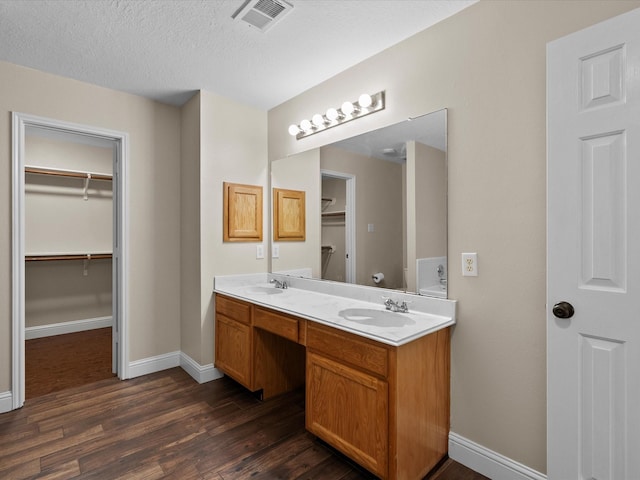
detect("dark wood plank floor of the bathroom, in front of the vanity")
(0, 368), (486, 480)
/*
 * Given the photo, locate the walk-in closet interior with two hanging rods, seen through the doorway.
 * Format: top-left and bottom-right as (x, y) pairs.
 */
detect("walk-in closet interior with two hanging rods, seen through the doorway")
(24, 128), (115, 400)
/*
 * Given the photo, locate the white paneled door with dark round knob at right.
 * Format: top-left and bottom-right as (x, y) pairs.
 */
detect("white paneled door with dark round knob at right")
(547, 9), (640, 480)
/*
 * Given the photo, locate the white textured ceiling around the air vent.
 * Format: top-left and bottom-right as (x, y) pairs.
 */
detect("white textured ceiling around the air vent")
(0, 0), (475, 110)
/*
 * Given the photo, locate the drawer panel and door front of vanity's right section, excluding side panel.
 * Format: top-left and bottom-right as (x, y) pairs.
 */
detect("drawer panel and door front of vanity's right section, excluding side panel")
(305, 325), (389, 478)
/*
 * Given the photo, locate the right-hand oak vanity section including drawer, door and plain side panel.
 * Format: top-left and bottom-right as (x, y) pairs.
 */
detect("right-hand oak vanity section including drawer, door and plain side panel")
(306, 323), (450, 480)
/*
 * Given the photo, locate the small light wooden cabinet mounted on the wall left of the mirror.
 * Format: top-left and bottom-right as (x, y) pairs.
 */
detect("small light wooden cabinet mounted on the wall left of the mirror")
(223, 182), (262, 242)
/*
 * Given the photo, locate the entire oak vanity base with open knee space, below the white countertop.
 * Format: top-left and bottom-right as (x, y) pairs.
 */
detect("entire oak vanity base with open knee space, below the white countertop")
(215, 295), (450, 480)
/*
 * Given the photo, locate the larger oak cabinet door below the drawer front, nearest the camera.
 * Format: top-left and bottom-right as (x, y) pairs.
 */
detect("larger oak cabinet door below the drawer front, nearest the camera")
(306, 352), (389, 478)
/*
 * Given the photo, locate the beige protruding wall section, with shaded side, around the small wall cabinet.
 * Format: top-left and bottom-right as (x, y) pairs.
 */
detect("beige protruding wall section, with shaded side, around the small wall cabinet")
(180, 91), (269, 365)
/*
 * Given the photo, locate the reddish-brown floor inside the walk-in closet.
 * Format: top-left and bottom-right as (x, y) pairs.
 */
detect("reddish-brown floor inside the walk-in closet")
(25, 327), (113, 399)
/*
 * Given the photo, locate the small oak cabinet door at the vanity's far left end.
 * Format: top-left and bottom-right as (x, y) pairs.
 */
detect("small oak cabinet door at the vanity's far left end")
(215, 312), (253, 390)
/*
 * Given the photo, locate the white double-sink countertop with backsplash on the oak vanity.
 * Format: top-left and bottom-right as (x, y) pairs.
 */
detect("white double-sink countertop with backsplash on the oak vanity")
(214, 273), (456, 346)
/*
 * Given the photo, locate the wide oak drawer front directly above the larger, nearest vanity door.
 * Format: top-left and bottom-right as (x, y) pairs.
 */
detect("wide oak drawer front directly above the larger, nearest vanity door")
(307, 322), (389, 378)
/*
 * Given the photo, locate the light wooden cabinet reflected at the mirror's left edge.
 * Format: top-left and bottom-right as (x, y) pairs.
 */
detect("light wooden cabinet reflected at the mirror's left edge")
(273, 188), (306, 242)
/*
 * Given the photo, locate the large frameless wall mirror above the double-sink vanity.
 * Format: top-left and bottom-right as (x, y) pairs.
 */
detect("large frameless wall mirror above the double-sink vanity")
(271, 109), (447, 298)
